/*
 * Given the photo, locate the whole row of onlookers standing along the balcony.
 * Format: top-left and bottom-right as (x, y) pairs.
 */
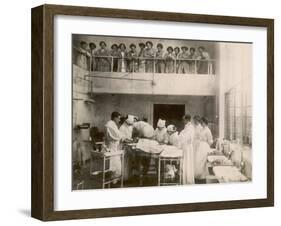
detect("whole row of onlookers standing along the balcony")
(75, 41), (212, 74)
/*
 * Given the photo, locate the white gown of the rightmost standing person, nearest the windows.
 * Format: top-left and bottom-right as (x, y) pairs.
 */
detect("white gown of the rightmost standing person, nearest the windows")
(195, 126), (213, 179)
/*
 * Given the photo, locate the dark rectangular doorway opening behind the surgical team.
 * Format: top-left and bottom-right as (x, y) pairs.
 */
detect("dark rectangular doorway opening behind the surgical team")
(153, 104), (185, 130)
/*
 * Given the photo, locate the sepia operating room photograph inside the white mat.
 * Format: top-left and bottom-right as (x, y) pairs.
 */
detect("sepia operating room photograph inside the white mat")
(72, 34), (250, 190)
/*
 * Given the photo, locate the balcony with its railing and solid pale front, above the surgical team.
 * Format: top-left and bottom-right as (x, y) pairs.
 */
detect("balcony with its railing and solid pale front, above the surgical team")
(73, 57), (216, 96)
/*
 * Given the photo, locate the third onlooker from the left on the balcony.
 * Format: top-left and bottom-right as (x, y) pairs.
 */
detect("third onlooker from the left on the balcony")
(96, 41), (111, 72)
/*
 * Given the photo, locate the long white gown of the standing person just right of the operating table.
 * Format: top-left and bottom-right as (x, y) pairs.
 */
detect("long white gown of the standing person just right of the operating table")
(179, 122), (194, 184)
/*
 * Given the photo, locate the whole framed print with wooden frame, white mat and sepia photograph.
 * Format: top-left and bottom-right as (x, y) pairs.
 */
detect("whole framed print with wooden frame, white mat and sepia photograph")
(32, 5), (274, 221)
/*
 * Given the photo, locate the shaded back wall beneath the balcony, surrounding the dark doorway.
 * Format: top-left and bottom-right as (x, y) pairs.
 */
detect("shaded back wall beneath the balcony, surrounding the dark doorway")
(93, 94), (215, 128)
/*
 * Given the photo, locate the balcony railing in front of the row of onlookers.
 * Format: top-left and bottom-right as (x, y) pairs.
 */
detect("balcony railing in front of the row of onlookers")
(74, 49), (216, 75)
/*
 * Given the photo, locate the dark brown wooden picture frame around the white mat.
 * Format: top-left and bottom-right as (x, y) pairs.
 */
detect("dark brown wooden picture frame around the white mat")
(31, 5), (274, 221)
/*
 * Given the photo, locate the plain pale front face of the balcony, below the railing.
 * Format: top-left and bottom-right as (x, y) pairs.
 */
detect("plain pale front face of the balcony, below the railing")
(90, 72), (216, 96)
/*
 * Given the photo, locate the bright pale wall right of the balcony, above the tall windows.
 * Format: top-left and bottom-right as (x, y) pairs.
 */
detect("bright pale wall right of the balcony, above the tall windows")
(216, 43), (253, 138)
